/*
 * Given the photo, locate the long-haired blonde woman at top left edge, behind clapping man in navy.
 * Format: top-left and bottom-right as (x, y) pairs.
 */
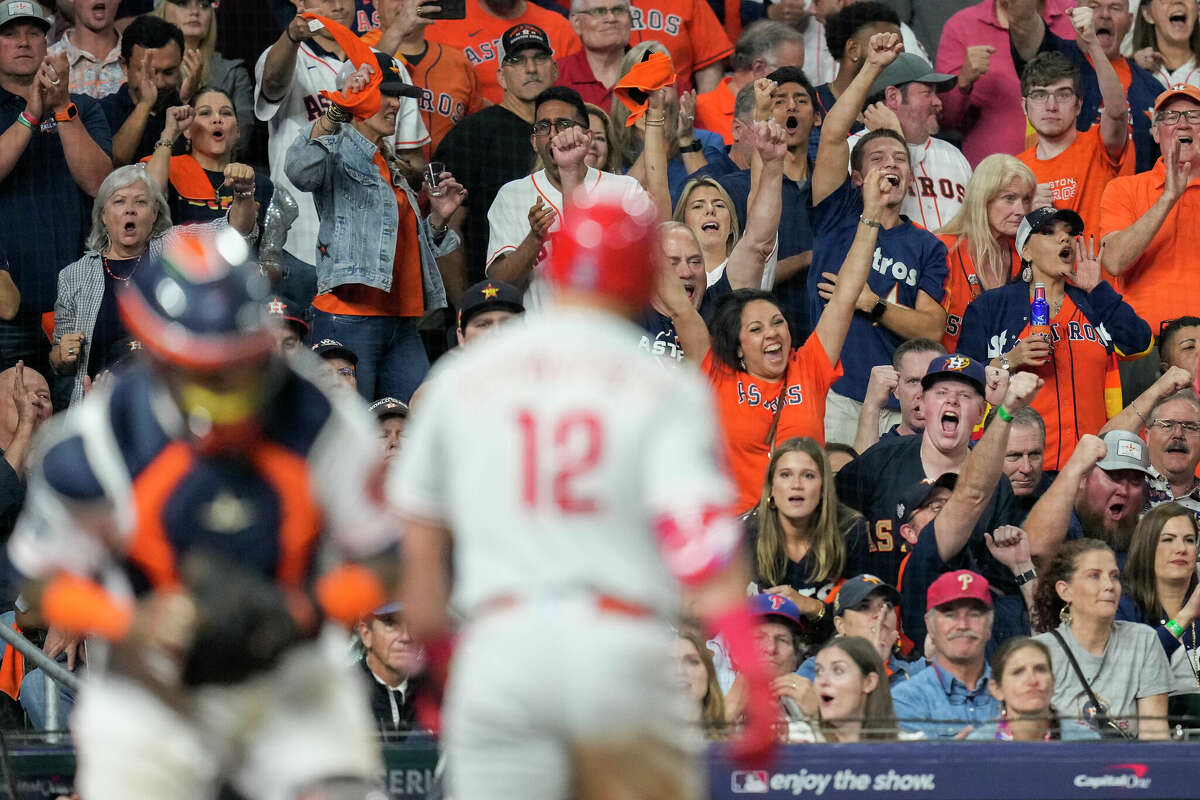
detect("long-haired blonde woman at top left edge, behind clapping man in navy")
(150, 0), (254, 157)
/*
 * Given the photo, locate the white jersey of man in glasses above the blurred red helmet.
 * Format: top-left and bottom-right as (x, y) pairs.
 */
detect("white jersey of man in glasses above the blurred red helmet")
(485, 167), (646, 311)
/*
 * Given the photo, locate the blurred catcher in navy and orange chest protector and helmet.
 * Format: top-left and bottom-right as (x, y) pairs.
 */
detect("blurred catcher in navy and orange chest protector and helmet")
(10, 226), (395, 800)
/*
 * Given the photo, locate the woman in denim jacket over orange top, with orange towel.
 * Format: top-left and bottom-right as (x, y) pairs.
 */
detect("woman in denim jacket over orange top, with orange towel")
(284, 48), (466, 401)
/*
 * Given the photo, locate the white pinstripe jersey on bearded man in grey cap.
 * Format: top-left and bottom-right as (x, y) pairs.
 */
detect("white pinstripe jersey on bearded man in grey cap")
(848, 131), (972, 233)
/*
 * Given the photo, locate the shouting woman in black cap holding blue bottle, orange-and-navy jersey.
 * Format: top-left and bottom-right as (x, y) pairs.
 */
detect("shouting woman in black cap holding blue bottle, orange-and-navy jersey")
(959, 207), (1153, 471)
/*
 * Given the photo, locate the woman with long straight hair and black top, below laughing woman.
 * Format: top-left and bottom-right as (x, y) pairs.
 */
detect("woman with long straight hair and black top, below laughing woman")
(746, 437), (869, 640)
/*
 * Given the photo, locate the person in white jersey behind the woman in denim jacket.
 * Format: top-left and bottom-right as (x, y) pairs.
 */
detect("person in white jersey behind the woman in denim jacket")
(254, 0), (430, 264)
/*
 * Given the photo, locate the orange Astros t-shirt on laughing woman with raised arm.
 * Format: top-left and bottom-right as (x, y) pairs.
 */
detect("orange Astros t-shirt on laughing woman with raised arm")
(701, 333), (841, 512)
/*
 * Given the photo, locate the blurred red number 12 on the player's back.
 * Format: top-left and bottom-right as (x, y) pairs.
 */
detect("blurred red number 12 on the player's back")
(516, 410), (604, 515)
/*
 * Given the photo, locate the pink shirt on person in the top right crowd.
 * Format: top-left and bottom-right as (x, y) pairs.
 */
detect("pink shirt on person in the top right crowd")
(937, 0), (1075, 167)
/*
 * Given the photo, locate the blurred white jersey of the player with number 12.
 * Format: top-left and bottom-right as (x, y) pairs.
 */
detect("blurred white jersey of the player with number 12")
(386, 306), (740, 616)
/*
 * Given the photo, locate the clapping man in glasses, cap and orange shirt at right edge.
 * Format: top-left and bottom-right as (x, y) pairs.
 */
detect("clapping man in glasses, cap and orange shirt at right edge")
(1100, 84), (1200, 340)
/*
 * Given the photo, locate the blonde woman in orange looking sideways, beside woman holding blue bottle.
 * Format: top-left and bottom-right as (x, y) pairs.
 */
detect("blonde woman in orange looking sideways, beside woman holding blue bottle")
(935, 154), (1038, 353)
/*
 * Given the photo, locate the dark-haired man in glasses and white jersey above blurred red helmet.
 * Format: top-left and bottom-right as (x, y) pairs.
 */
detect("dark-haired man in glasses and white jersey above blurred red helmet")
(487, 81), (646, 308)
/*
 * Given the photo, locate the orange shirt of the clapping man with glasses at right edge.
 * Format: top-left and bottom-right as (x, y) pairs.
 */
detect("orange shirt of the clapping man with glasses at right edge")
(1099, 158), (1200, 331)
